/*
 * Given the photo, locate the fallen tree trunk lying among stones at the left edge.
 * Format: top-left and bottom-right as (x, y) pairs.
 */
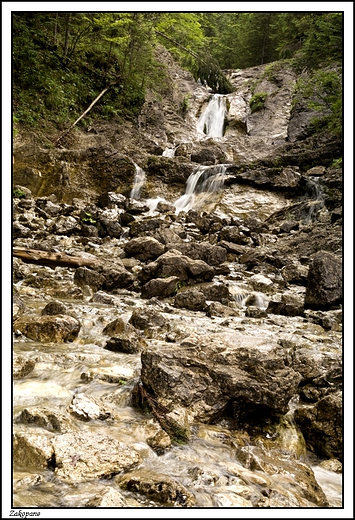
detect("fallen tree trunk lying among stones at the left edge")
(13, 247), (102, 269)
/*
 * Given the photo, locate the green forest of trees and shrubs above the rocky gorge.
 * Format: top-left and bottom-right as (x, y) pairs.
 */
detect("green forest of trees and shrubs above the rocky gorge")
(12, 12), (343, 135)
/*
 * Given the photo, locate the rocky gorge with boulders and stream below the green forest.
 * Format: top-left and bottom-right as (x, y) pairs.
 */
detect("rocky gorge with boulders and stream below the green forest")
(12, 49), (343, 508)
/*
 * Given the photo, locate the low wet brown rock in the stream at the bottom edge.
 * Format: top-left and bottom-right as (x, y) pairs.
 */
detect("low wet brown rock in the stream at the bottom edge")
(115, 468), (196, 507)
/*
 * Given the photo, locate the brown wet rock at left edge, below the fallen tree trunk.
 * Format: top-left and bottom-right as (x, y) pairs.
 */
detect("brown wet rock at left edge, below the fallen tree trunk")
(14, 314), (80, 343)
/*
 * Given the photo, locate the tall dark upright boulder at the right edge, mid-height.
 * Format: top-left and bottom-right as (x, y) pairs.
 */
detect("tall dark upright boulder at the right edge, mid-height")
(305, 251), (343, 309)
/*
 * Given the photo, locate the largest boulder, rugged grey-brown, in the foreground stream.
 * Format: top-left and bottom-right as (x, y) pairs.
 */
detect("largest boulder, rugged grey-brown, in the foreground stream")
(141, 333), (301, 430)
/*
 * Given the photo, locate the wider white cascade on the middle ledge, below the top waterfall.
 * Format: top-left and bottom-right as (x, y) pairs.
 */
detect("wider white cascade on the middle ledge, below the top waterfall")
(174, 164), (228, 215)
